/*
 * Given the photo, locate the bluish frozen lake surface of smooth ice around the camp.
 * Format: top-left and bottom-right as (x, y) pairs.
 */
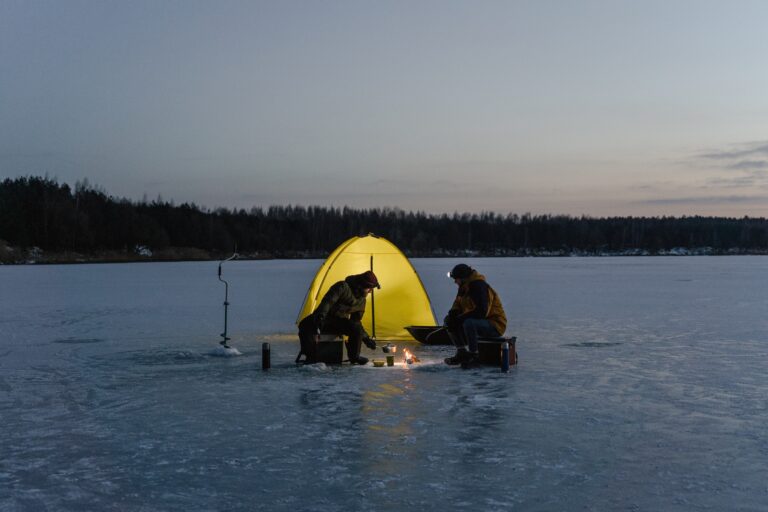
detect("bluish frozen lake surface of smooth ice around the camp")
(0, 257), (768, 511)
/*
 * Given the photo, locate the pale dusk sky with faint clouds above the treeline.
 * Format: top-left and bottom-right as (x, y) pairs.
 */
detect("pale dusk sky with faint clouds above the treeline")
(0, 0), (768, 217)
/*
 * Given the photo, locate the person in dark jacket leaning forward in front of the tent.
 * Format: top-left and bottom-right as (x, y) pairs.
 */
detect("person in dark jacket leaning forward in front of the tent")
(299, 270), (381, 364)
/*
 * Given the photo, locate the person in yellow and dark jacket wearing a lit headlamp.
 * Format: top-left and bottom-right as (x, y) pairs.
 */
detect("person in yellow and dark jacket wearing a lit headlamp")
(444, 263), (507, 368)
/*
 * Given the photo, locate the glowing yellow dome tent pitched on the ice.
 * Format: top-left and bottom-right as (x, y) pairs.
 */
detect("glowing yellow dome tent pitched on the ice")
(296, 234), (435, 340)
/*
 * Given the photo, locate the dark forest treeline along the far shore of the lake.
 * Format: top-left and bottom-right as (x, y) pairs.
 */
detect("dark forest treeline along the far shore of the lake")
(0, 177), (768, 257)
